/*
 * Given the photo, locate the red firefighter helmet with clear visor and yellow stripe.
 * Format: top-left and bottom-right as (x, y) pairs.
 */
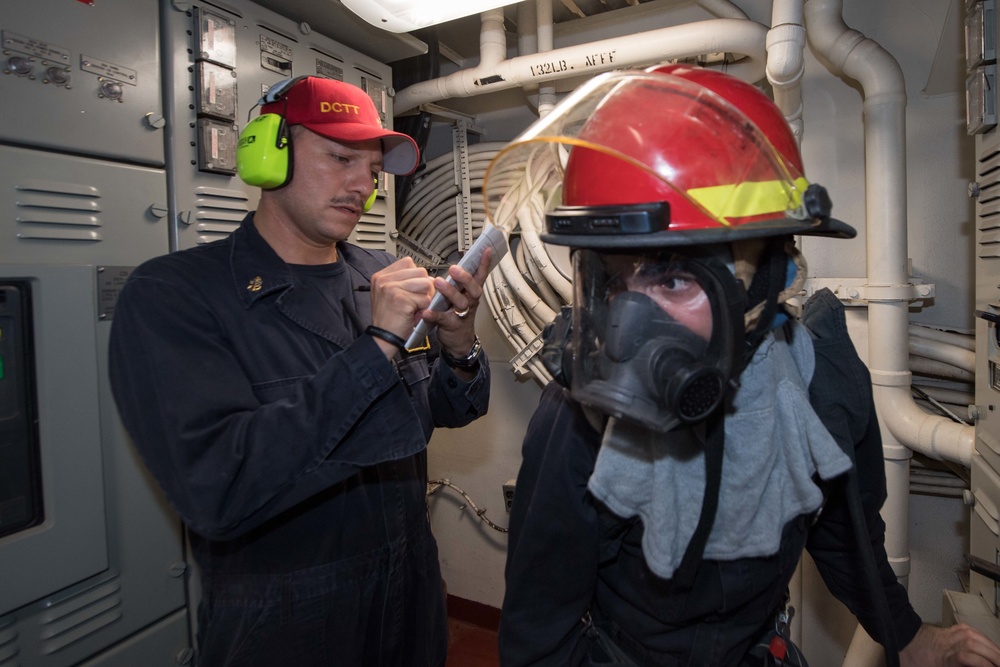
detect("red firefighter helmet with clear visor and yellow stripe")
(483, 71), (849, 247)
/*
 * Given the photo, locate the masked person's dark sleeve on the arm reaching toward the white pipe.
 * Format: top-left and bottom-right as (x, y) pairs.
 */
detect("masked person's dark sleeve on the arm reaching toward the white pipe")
(805, 295), (920, 648)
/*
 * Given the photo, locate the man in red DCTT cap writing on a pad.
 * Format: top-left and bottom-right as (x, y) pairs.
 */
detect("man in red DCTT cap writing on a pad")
(110, 77), (489, 667)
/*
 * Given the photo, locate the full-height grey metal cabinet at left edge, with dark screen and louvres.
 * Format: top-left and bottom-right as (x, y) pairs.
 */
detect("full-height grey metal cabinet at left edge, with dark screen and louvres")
(0, 0), (190, 667)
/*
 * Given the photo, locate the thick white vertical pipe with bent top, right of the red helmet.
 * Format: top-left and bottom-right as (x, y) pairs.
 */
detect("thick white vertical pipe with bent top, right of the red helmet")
(805, 0), (919, 667)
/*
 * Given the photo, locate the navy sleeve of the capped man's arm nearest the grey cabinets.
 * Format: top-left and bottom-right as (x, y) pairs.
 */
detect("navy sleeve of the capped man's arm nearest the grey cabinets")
(109, 270), (485, 540)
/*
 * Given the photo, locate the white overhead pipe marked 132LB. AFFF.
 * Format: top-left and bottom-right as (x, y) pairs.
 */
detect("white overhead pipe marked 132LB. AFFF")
(393, 17), (767, 114)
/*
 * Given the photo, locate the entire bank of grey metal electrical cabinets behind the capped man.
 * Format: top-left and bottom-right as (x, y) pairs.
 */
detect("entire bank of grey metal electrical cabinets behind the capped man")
(0, 0), (406, 667)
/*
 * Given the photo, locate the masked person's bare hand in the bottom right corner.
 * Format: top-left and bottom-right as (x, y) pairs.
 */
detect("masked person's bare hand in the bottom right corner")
(899, 623), (1000, 667)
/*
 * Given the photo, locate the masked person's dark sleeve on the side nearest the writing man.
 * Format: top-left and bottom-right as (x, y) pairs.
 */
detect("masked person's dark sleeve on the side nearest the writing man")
(499, 382), (598, 667)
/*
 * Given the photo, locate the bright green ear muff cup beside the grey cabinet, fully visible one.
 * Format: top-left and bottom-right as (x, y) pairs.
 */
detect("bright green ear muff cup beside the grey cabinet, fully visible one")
(236, 113), (292, 190)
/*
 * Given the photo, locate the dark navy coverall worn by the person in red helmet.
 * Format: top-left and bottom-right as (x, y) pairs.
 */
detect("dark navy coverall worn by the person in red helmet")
(499, 291), (920, 667)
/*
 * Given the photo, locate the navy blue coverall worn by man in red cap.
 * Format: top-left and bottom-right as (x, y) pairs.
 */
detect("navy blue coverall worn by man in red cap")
(110, 214), (490, 667)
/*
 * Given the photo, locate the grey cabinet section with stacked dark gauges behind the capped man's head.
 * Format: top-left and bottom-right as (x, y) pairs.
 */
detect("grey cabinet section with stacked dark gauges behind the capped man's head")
(163, 0), (395, 252)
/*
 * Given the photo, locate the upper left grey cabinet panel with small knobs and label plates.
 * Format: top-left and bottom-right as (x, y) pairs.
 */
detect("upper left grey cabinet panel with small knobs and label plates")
(0, 0), (163, 166)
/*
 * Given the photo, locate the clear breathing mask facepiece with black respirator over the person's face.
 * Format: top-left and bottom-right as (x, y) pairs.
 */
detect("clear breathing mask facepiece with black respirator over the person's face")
(570, 249), (743, 432)
